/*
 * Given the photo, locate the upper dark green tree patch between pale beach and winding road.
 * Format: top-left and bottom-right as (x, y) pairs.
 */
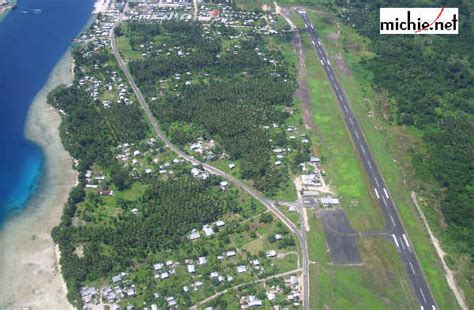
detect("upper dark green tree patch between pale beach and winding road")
(48, 86), (149, 171)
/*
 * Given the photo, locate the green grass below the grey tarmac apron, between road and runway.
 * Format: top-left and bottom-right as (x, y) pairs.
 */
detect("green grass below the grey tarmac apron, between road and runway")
(308, 216), (417, 309)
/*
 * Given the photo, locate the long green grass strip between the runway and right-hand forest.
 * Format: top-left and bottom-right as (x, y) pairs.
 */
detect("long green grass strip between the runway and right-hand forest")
(302, 12), (458, 309)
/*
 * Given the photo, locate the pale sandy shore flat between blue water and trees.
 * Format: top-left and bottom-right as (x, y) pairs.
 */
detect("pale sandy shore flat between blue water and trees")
(0, 53), (77, 309)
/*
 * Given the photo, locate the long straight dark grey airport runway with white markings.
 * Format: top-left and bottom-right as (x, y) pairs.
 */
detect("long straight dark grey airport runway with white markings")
(298, 10), (435, 309)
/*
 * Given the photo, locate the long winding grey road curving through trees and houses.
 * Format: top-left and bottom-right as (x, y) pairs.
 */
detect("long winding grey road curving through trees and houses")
(110, 17), (309, 309)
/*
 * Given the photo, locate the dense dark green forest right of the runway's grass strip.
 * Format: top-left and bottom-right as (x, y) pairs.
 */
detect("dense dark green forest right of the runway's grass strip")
(335, 0), (474, 255)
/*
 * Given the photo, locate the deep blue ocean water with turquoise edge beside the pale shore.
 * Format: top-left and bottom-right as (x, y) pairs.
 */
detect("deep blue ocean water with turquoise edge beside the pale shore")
(0, 0), (94, 227)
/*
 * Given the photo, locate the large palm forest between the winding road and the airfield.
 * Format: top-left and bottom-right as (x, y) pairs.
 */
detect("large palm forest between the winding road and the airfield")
(125, 21), (309, 193)
